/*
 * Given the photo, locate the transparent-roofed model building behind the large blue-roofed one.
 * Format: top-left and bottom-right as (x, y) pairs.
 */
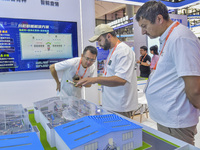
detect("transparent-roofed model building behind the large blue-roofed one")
(34, 97), (110, 147)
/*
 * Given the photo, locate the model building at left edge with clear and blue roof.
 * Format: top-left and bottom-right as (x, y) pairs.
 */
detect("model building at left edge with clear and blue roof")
(0, 104), (44, 150)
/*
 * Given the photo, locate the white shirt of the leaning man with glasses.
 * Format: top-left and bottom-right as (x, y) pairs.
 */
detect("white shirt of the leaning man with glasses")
(55, 57), (95, 98)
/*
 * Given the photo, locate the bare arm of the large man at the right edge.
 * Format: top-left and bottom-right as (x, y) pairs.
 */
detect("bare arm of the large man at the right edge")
(183, 76), (200, 109)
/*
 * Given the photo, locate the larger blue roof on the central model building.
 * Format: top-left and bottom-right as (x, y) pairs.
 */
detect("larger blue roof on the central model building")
(54, 114), (142, 149)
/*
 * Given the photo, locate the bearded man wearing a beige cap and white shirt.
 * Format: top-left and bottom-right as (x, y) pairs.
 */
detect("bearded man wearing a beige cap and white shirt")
(77, 24), (138, 118)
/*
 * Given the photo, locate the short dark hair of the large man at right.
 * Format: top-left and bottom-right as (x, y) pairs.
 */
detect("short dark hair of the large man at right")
(136, 1), (169, 24)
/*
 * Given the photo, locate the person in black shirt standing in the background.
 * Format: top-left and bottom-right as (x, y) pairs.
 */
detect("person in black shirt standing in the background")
(137, 46), (151, 78)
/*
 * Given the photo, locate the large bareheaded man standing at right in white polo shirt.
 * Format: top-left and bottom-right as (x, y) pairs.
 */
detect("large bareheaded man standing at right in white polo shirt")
(136, 1), (200, 144)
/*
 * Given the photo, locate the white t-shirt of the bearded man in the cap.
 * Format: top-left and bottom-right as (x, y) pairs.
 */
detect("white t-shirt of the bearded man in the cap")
(102, 42), (138, 112)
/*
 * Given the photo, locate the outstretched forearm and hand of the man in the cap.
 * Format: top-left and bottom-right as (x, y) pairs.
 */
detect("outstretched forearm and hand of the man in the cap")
(77, 76), (126, 87)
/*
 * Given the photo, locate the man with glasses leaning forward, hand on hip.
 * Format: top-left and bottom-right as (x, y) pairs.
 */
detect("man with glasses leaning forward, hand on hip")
(49, 46), (97, 98)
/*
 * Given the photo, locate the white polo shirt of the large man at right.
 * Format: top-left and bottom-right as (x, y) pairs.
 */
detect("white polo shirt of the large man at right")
(146, 23), (200, 128)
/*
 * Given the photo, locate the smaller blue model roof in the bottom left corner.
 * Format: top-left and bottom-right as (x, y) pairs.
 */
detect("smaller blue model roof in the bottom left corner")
(0, 132), (44, 150)
